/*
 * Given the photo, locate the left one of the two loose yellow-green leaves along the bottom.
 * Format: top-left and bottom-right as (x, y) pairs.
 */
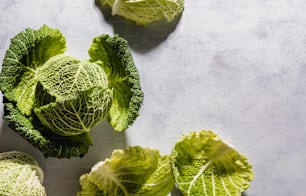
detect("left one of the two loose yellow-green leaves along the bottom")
(78, 146), (174, 196)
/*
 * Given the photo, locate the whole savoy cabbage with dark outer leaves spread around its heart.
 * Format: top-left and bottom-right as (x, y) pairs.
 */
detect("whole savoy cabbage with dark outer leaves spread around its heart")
(0, 25), (143, 158)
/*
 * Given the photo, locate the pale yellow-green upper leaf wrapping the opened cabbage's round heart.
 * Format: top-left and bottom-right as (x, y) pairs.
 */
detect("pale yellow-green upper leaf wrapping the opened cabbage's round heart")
(36, 55), (108, 100)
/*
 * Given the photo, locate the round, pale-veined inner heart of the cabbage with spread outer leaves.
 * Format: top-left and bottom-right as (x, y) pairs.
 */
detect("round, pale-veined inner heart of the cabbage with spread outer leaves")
(34, 55), (112, 136)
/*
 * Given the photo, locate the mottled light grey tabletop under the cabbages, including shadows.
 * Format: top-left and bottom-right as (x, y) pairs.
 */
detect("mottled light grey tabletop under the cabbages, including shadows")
(0, 0), (306, 196)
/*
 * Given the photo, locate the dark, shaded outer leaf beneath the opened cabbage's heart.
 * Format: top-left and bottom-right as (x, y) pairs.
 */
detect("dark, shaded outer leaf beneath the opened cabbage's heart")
(4, 103), (92, 158)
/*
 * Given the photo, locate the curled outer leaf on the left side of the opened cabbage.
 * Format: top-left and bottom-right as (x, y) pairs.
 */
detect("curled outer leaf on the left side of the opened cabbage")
(0, 25), (66, 115)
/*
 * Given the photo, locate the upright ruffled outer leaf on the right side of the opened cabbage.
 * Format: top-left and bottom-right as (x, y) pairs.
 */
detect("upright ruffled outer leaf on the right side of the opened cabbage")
(88, 34), (144, 131)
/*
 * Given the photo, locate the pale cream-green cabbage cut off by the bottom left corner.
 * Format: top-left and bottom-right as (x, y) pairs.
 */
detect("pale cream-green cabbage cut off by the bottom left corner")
(0, 151), (46, 196)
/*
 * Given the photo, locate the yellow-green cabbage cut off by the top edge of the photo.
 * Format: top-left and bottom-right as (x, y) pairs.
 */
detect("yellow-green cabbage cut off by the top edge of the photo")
(100, 0), (184, 25)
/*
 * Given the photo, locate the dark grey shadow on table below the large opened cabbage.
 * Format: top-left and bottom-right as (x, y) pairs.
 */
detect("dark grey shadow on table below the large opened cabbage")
(0, 115), (127, 196)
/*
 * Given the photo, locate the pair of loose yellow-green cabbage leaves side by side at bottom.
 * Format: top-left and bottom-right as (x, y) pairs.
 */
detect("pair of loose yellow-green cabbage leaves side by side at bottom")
(78, 130), (254, 196)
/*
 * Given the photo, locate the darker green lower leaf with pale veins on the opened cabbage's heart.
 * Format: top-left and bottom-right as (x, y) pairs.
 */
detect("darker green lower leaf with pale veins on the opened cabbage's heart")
(34, 87), (112, 136)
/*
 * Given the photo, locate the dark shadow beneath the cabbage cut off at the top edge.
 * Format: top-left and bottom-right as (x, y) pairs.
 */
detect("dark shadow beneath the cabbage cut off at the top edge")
(95, 0), (182, 53)
